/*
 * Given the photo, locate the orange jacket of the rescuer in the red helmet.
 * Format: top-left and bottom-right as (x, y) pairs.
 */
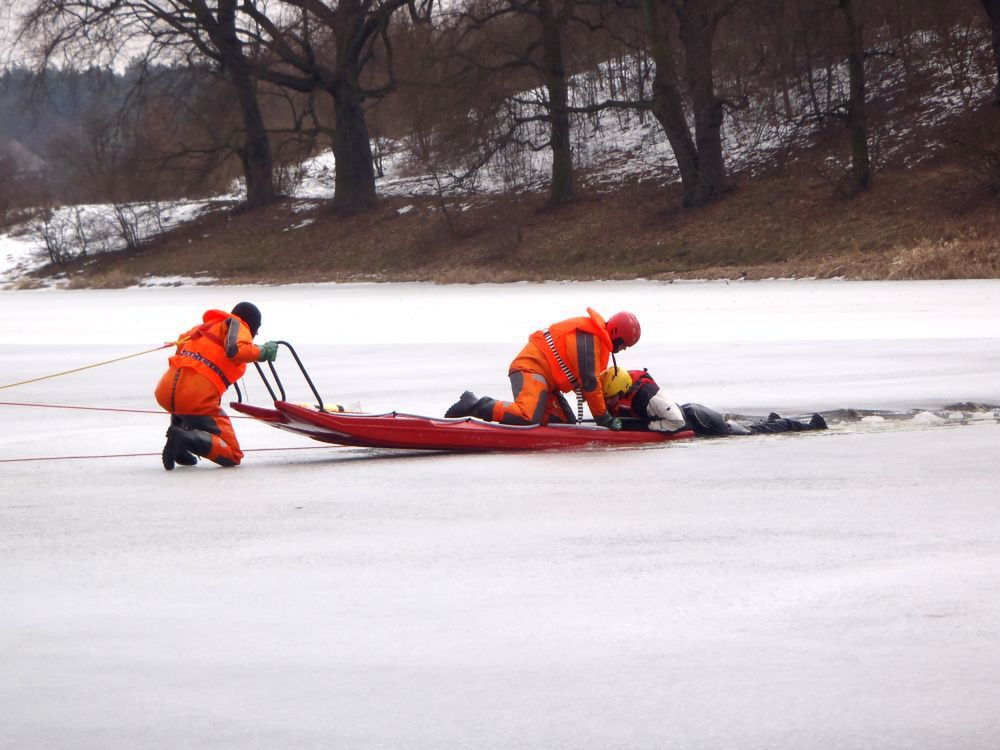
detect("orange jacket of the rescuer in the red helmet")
(511, 307), (614, 418)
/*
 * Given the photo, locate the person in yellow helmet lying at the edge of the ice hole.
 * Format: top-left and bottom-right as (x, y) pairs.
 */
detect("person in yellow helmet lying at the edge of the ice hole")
(600, 367), (826, 436)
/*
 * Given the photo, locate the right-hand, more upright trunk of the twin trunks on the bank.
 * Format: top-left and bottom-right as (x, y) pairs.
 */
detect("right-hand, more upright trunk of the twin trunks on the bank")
(677, 0), (726, 204)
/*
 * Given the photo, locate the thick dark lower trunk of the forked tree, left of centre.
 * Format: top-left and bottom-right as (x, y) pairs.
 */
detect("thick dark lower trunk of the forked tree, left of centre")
(327, 75), (375, 212)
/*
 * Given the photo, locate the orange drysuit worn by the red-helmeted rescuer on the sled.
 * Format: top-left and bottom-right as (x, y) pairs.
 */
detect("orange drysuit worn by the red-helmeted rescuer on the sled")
(493, 307), (614, 424)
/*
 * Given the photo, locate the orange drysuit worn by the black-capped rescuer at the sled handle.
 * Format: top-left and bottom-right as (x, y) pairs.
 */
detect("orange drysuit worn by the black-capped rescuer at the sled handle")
(156, 310), (260, 466)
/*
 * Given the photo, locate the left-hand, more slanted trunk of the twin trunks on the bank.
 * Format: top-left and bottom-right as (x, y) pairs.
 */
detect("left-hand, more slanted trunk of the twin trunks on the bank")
(642, 0), (700, 207)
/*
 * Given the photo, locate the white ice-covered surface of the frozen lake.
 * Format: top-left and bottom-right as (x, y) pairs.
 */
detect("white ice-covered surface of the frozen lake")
(0, 281), (1000, 750)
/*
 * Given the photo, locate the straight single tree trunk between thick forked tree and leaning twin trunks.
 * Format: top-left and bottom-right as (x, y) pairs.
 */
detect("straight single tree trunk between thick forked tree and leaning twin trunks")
(538, 0), (573, 206)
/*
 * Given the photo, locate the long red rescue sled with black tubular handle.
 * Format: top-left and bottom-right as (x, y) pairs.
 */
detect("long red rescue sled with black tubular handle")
(230, 341), (694, 452)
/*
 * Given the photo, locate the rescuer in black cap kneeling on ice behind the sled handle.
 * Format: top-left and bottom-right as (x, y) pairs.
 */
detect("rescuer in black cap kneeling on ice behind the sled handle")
(156, 302), (278, 471)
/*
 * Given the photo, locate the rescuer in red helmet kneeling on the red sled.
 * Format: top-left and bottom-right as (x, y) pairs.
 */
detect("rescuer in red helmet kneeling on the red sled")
(445, 307), (640, 430)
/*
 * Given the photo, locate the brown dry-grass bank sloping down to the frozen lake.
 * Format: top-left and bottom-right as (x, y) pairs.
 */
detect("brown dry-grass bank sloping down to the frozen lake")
(37, 156), (1000, 288)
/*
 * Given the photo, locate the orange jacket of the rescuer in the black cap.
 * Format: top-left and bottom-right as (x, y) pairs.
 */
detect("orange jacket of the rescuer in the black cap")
(170, 310), (260, 396)
